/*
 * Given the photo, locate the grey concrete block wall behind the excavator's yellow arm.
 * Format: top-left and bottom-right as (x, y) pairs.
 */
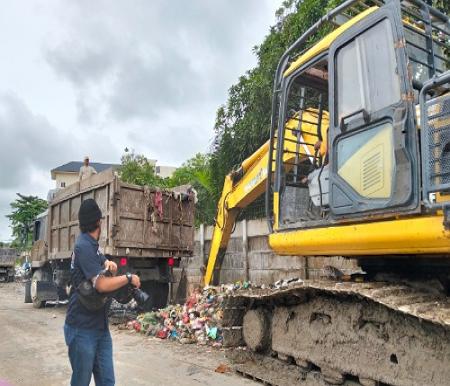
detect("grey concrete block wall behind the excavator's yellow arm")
(173, 219), (356, 301)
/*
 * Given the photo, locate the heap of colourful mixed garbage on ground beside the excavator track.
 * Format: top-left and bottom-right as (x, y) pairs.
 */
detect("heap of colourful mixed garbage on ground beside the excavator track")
(127, 282), (250, 347)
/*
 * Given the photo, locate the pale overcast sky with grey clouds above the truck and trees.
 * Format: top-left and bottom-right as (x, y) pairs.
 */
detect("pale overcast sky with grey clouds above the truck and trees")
(0, 0), (280, 240)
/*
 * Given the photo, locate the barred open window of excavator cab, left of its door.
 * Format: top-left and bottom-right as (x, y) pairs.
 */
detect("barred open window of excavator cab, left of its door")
(279, 58), (328, 228)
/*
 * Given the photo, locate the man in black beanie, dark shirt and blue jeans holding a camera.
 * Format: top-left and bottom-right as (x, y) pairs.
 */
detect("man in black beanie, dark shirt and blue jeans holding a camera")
(64, 199), (140, 386)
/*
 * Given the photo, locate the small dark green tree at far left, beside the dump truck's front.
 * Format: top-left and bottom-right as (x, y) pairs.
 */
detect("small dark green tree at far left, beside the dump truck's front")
(6, 193), (47, 250)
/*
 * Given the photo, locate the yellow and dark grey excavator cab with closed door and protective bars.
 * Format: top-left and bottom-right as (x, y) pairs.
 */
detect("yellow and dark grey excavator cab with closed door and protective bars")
(266, 1), (450, 231)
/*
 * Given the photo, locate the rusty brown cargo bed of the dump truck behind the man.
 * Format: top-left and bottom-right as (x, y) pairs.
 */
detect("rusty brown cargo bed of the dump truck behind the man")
(47, 170), (194, 260)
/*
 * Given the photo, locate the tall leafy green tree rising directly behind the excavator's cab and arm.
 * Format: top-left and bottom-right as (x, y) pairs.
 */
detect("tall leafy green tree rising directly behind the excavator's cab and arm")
(211, 0), (340, 202)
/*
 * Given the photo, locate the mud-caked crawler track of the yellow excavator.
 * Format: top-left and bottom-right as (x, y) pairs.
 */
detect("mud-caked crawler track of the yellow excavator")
(223, 281), (450, 386)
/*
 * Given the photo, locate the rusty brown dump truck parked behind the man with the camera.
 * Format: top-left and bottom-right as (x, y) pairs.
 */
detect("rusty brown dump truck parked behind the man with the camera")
(25, 169), (195, 308)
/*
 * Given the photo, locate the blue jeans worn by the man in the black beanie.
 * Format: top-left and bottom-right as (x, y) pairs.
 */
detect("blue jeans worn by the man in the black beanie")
(64, 324), (115, 386)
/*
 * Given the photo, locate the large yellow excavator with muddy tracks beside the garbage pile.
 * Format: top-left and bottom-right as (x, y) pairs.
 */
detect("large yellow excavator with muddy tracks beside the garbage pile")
(204, 0), (450, 386)
